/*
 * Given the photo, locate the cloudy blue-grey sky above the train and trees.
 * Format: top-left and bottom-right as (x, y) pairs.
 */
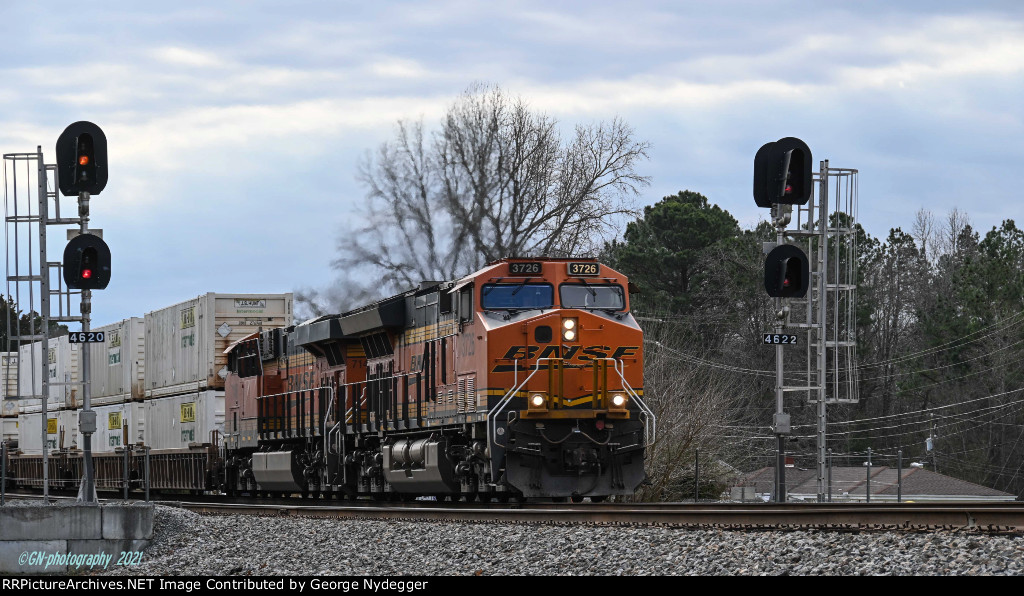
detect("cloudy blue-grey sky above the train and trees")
(0, 0), (1024, 325)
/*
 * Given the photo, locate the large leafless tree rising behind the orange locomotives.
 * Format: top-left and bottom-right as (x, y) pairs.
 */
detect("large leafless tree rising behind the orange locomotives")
(322, 85), (648, 311)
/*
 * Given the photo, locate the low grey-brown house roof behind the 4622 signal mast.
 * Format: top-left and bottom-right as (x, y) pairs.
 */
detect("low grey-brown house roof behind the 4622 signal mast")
(739, 466), (1014, 499)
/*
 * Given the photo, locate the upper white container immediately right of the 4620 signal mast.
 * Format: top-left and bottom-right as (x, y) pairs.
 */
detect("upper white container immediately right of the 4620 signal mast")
(86, 316), (145, 407)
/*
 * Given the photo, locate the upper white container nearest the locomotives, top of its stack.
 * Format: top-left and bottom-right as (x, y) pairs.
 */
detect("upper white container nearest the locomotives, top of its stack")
(144, 293), (292, 398)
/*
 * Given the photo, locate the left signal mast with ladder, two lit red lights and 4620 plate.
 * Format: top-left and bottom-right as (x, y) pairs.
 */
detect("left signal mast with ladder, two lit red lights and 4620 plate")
(3, 122), (111, 502)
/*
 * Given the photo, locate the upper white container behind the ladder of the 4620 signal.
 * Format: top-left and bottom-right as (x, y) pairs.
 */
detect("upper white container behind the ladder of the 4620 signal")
(18, 335), (82, 409)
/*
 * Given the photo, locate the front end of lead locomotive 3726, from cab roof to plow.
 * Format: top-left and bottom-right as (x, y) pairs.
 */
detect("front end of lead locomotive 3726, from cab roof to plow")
(468, 259), (653, 499)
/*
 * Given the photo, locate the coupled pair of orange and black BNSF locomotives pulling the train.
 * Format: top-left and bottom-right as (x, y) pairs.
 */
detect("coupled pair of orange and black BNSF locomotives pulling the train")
(222, 259), (655, 501)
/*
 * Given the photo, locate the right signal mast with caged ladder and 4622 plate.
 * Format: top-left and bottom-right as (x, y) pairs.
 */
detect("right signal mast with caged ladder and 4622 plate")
(754, 137), (857, 502)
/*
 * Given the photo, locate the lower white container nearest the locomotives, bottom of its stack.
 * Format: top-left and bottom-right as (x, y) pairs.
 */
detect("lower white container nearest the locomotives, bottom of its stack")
(143, 390), (224, 450)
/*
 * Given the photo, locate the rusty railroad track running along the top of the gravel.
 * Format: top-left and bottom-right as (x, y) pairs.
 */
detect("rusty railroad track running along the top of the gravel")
(8, 493), (1024, 534)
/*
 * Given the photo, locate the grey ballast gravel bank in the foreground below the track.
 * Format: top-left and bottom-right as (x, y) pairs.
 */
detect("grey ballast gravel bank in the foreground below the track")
(97, 506), (1024, 576)
